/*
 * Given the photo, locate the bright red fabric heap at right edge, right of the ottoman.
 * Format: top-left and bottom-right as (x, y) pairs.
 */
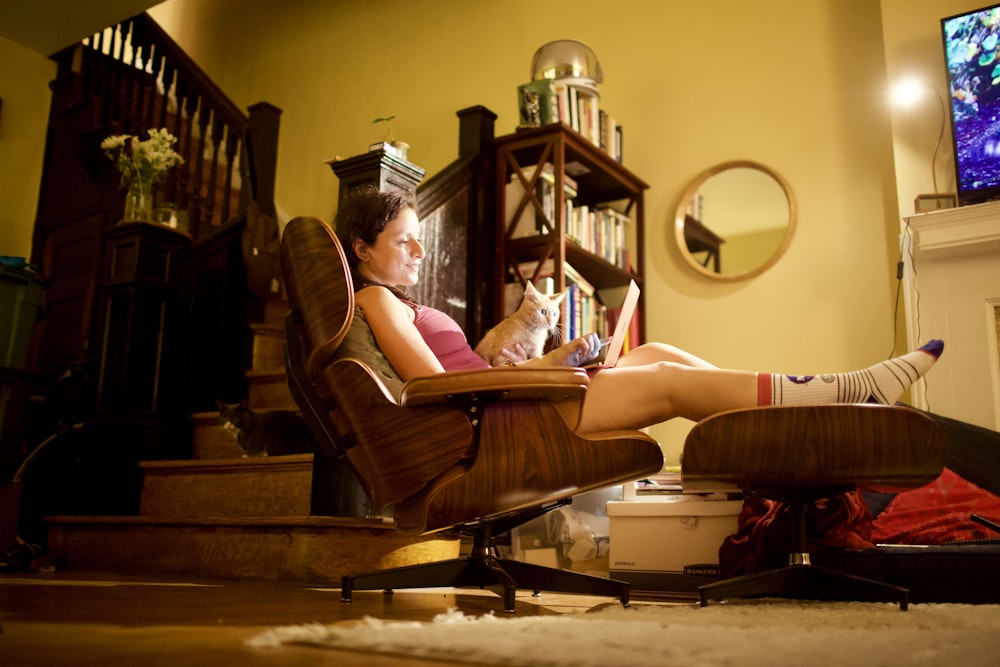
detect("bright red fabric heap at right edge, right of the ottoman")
(872, 468), (1000, 544)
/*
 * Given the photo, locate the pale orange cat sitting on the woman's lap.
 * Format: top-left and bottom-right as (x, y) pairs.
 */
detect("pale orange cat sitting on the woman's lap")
(476, 282), (566, 366)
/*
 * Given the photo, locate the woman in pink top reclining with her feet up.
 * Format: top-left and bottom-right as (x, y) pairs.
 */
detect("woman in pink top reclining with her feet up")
(336, 190), (944, 433)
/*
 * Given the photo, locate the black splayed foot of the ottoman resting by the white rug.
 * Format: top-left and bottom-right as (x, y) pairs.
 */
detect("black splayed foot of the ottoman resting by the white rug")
(698, 564), (910, 611)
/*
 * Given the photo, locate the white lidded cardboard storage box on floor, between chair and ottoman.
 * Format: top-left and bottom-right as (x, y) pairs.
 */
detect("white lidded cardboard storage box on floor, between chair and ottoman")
(608, 495), (743, 597)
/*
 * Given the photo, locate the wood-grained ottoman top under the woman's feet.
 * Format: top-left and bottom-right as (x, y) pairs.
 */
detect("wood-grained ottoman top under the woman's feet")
(682, 405), (946, 491)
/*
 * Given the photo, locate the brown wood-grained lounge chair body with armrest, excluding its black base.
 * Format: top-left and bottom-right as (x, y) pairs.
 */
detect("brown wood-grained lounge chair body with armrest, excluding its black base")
(281, 218), (663, 533)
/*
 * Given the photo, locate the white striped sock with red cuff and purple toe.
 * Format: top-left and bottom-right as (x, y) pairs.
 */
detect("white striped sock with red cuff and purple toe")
(757, 340), (944, 405)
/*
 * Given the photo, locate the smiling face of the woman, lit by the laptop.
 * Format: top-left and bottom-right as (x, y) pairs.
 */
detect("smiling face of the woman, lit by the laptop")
(354, 208), (424, 285)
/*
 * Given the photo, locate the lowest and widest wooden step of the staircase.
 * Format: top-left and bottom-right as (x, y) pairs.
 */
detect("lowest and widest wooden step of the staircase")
(46, 516), (460, 586)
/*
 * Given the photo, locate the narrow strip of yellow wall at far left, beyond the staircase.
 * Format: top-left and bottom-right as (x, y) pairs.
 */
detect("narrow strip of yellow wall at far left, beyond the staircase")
(0, 37), (56, 257)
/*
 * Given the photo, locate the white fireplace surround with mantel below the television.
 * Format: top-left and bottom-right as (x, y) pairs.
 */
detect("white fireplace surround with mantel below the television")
(900, 202), (1000, 430)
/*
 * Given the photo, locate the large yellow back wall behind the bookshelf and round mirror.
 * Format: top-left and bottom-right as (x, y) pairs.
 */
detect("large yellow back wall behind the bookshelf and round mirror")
(0, 0), (975, 457)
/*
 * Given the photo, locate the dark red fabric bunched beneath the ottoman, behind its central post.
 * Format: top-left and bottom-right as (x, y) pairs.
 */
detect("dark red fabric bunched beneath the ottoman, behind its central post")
(719, 491), (875, 578)
